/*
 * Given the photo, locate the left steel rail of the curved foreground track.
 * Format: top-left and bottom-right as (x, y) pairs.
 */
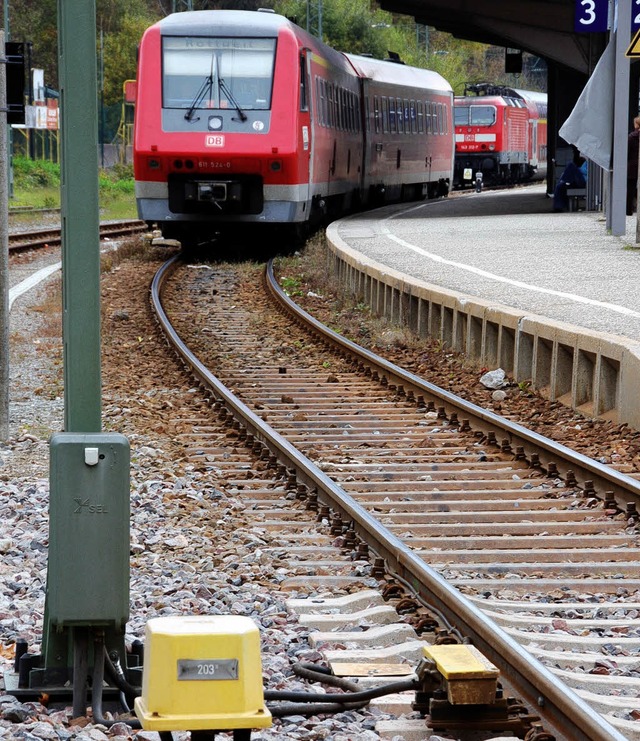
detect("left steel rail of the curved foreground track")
(150, 255), (626, 741)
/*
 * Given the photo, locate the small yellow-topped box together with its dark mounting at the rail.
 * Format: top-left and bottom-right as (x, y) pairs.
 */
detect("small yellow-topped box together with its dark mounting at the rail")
(412, 644), (553, 741)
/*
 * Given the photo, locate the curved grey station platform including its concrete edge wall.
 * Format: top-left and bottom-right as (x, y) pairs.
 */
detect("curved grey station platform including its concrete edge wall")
(327, 185), (640, 428)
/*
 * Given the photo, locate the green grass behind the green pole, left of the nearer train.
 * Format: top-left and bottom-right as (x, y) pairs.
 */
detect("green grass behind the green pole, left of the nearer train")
(9, 157), (137, 221)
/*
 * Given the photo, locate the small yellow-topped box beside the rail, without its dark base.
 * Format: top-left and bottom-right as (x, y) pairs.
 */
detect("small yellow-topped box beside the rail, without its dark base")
(422, 643), (500, 705)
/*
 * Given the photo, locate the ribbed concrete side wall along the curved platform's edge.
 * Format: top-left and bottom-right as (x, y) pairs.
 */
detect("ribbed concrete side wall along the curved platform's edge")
(327, 227), (640, 429)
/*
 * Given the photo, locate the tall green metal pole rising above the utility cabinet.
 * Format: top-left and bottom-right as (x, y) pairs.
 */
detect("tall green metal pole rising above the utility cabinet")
(58, 0), (101, 432)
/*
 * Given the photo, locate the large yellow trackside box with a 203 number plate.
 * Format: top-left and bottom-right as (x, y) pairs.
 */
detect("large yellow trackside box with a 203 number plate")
(135, 615), (271, 732)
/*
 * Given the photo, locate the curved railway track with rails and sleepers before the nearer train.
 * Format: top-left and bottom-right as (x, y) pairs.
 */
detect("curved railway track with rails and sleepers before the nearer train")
(148, 254), (640, 739)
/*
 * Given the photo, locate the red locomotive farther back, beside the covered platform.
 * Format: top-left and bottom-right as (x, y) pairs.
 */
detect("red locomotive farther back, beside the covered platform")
(453, 83), (547, 188)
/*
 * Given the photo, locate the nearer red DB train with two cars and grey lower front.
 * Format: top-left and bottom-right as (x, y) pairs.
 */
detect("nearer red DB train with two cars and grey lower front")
(134, 10), (455, 244)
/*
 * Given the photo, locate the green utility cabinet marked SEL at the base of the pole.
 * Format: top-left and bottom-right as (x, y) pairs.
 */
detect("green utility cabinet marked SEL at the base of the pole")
(47, 433), (130, 632)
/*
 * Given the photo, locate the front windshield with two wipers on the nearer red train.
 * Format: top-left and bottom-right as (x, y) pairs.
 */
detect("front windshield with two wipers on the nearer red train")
(162, 36), (276, 111)
